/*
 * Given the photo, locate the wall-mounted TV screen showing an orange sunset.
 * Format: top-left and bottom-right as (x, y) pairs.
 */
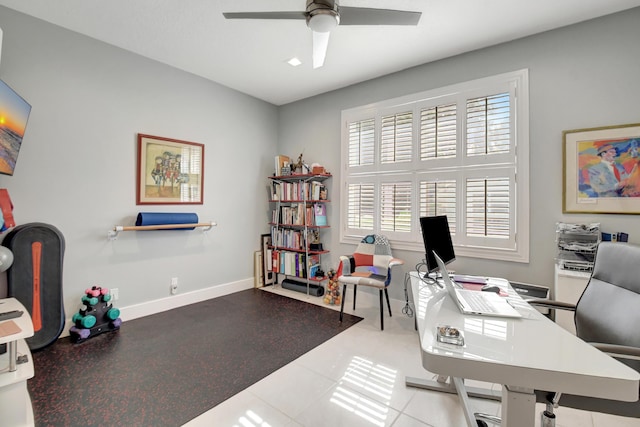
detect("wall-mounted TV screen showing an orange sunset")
(0, 80), (31, 175)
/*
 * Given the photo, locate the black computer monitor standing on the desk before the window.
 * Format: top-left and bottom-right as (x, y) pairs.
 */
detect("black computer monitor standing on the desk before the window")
(420, 215), (456, 273)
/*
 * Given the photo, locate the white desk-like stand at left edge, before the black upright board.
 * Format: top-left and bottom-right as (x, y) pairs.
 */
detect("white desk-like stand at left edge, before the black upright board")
(0, 298), (34, 426)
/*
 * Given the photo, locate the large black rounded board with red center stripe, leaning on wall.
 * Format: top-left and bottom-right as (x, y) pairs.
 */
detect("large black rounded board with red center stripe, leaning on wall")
(2, 222), (65, 350)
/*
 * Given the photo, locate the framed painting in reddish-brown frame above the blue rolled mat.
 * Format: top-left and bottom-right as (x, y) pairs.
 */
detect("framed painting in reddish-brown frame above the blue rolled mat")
(136, 134), (204, 205)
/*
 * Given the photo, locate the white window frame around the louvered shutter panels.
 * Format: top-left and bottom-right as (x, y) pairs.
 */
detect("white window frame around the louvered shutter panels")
(340, 69), (529, 262)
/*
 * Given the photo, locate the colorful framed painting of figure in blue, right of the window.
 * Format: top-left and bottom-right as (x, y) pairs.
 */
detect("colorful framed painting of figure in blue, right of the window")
(562, 123), (640, 214)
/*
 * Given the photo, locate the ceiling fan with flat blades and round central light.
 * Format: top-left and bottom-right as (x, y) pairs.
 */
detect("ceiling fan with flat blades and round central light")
(223, 0), (422, 68)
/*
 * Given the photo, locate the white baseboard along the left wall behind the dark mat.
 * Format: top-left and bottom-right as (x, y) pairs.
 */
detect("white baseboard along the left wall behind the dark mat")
(60, 278), (253, 338)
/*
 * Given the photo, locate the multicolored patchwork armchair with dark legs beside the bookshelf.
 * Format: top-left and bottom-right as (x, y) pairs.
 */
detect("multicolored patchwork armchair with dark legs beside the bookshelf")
(337, 234), (404, 330)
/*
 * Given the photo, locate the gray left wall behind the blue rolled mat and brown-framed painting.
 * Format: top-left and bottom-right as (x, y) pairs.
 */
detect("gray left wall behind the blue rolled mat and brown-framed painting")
(0, 7), (278, 317)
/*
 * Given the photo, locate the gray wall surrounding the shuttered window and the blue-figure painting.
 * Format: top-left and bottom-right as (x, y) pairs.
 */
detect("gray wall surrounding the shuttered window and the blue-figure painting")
(279, 9), (640, 298)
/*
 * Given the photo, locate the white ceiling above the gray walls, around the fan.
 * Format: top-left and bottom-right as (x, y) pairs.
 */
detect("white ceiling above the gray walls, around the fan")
(0, 0), (640, 105)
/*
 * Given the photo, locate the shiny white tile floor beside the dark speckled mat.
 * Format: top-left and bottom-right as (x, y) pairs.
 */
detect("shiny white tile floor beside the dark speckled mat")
(185, 287), (640, 427)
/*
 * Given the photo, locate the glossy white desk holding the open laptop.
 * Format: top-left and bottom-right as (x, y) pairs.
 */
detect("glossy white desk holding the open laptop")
(407, 272), (640, 427)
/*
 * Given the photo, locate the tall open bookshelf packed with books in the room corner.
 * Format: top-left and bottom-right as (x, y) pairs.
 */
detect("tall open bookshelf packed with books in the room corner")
(267, 174), (331, 295)
